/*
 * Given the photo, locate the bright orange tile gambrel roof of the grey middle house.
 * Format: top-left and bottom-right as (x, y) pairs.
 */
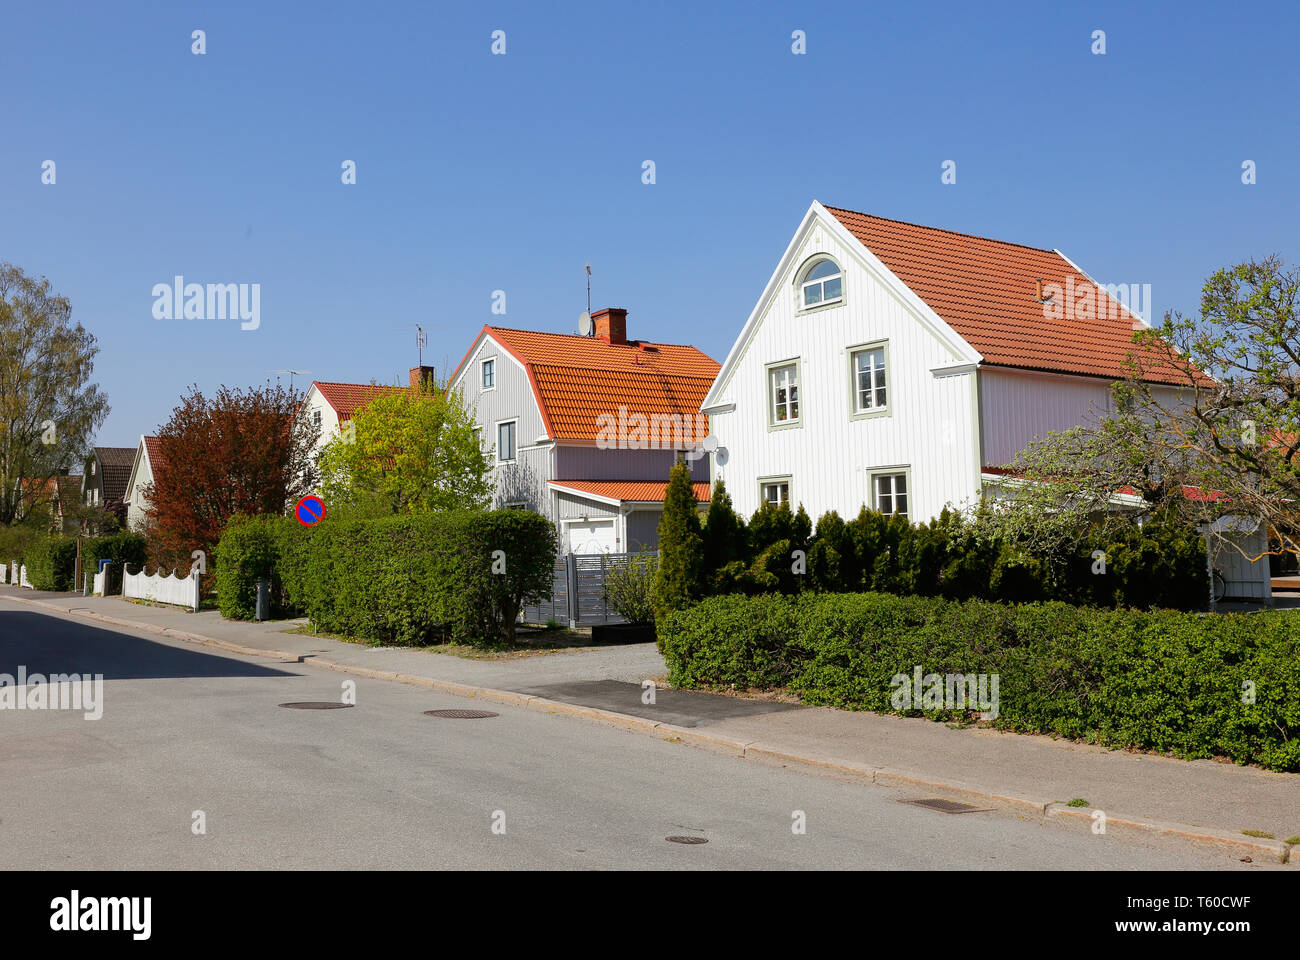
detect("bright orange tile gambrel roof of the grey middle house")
(452, 327), (719, 440)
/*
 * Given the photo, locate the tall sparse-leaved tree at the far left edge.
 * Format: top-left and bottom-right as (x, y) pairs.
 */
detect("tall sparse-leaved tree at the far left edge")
(0, 264), (108, 524)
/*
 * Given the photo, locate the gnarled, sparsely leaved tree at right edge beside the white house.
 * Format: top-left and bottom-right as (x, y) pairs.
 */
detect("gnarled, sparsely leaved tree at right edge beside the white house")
(988, 258), (1300, 559)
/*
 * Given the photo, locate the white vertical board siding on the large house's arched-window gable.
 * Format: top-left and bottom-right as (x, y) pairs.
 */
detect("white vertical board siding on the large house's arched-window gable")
(710, 214), (980, 522)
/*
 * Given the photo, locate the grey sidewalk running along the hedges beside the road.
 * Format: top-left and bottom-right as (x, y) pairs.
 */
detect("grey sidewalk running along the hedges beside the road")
(0, 585), (1300, 865)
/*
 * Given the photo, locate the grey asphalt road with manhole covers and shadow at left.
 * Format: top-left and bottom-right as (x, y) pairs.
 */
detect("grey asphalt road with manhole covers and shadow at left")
(0, 600), (1266, 870)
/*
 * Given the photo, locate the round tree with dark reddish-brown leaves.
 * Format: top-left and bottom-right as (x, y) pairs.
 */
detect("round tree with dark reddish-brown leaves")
(146, 382), (317, 568)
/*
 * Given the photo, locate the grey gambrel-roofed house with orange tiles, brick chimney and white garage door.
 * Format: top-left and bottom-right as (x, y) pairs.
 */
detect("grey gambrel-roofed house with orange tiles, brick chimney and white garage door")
(449, 308), (718, 553)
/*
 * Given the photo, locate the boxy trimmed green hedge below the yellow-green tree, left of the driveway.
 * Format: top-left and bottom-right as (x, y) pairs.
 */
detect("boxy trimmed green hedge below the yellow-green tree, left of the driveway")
(306, 510), (556, 645)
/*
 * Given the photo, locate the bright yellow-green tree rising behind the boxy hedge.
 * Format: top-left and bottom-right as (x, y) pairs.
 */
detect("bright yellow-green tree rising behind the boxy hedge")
(320, 384), (491, 514)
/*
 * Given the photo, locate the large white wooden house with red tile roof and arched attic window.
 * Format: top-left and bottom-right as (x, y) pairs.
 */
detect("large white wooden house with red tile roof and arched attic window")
(703, 202), (1177, 522)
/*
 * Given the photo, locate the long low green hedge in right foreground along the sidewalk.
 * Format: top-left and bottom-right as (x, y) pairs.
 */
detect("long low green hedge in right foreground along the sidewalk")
(658, 593), (1300, 770)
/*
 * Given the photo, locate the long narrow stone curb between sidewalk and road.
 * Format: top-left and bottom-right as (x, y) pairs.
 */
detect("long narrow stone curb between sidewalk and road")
(8, 596), (1300, 865)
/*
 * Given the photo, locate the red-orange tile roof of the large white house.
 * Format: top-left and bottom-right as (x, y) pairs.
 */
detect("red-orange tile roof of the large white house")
(827, 207), (1186, 382)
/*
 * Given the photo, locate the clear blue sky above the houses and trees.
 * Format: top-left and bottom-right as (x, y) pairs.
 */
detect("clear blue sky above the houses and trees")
(0, 3), (1300, 446)
